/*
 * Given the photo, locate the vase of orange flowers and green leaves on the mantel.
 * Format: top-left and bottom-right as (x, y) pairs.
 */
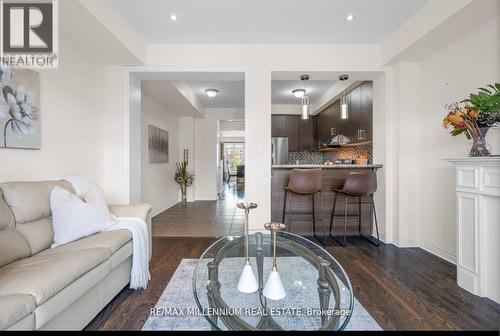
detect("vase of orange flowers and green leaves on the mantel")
(443, 83), (500, 156)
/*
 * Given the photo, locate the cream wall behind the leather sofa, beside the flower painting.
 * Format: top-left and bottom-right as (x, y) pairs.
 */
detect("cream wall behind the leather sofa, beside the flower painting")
(0, 39), (106, 191)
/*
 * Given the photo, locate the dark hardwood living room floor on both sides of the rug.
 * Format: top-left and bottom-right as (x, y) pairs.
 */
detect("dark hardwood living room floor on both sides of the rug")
(87, 237), (500, 330)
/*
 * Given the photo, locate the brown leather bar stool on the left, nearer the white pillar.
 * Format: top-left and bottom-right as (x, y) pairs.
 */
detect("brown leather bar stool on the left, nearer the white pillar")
(283, 168), (326, 245)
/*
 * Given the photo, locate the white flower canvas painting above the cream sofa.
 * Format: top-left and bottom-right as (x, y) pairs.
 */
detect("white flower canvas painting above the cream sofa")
(0, 67), (40, 149)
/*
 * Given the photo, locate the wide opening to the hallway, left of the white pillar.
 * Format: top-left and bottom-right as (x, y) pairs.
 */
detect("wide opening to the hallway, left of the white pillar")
(130, 72), (245, 237)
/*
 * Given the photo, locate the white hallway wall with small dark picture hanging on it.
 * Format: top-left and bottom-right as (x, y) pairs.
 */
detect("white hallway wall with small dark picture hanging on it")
(141, 90), (179, 215)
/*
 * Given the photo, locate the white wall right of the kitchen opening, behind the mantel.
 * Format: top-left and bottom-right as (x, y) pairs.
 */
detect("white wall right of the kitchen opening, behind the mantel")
(374, 17), (500, 262)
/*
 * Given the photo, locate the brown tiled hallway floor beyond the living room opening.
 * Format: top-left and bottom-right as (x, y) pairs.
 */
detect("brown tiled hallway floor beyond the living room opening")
(152, 177), (245, 237)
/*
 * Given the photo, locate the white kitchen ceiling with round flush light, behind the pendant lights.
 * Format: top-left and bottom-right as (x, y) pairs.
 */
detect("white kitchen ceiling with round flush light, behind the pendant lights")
(271, 80), (336, 104)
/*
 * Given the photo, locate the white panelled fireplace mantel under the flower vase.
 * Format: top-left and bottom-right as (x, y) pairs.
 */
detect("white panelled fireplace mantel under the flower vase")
(446, 156), (500, 302)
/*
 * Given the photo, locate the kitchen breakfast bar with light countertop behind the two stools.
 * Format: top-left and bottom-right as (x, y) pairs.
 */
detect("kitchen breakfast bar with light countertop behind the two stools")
(271, 164), (382, 236)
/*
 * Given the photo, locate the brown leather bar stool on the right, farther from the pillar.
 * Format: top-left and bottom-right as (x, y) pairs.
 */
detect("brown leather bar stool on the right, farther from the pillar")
(329, 171), (380, 246)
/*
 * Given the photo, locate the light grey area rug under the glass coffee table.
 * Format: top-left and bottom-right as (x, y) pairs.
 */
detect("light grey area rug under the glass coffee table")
(142, 259), (382, 330)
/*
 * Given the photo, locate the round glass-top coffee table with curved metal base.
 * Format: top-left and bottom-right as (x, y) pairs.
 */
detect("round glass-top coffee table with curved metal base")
(193, 232), (354, 330)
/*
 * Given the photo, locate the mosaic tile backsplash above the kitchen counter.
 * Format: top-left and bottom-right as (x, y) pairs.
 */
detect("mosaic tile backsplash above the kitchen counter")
(288, 144), (373, 164)
